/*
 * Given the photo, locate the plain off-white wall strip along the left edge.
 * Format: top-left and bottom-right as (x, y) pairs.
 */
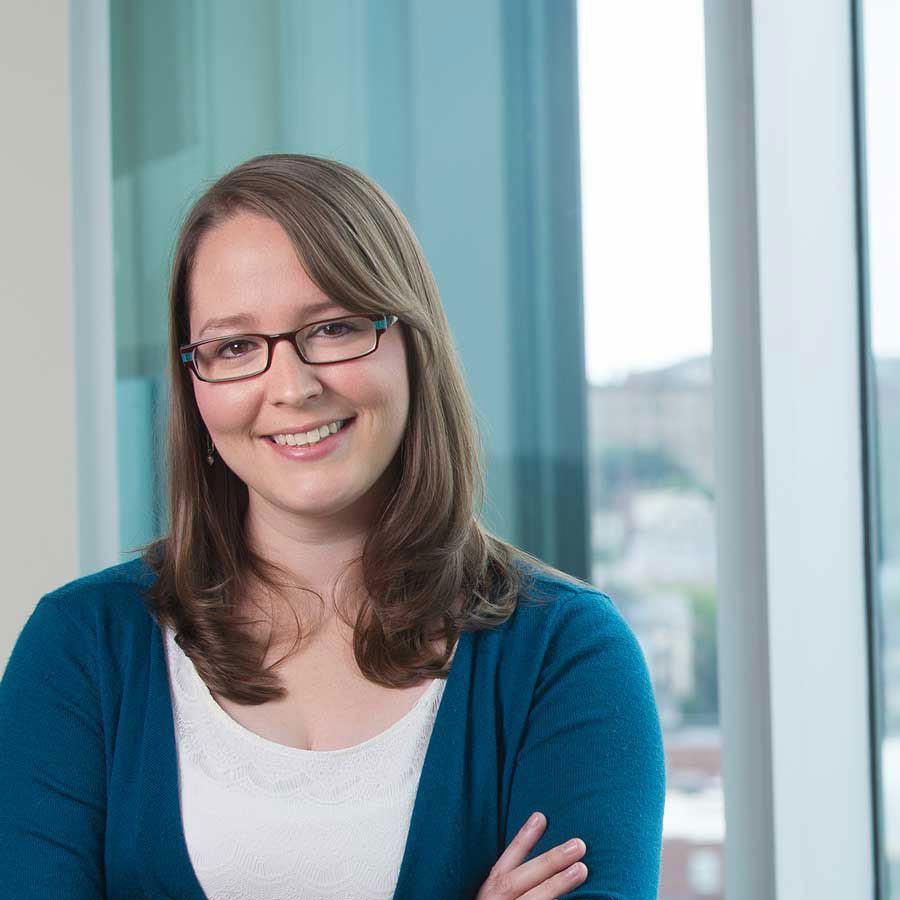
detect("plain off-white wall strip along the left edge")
(0, 0), (78, 666)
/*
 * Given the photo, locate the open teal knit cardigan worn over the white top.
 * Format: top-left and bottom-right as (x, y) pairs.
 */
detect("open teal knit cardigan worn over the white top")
(0, 560), (665, 900)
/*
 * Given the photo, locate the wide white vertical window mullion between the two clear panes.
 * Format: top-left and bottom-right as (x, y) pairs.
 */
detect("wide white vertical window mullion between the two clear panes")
(706, 0), (874, 900)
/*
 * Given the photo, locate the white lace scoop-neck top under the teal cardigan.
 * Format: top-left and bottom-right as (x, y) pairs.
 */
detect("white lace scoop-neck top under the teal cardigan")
(165, 629), (446, 900)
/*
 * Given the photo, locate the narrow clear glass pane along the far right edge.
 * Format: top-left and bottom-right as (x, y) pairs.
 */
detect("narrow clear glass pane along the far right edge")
(860, 0), (900, 900)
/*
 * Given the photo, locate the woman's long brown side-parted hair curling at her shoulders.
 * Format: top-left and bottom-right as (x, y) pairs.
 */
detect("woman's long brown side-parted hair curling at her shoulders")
(135, 154), (584, 704)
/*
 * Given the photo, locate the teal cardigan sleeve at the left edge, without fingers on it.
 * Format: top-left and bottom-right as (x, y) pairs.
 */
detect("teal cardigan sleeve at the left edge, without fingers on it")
(0, 597), (106, 900)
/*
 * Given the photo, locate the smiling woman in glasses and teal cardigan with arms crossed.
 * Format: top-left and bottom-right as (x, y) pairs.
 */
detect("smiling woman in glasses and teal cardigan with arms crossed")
(0, 155), (664, 900)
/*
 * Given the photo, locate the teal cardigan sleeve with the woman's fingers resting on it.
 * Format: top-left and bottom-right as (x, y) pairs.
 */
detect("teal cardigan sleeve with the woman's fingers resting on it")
(506, 591), (665, 900)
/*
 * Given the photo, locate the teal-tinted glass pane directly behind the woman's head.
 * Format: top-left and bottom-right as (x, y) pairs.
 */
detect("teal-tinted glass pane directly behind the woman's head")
(110, 0), (588, 577)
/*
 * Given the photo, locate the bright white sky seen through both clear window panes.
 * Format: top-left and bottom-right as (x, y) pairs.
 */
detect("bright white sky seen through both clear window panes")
(578, 0), (900, 382)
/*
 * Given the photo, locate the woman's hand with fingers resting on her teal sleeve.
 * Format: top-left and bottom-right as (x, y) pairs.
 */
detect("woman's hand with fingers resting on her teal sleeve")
(475, 813), (587, 900)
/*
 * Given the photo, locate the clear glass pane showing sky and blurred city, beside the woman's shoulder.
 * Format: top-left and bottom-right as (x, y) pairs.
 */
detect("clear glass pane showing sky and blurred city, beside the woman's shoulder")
(578, 0), (725, 900)
